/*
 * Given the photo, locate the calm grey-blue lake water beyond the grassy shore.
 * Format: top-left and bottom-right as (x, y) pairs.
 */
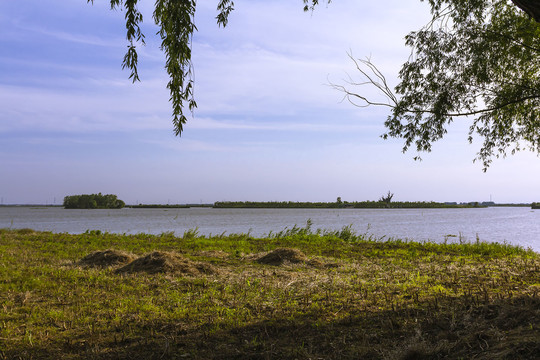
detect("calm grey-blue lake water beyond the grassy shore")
(0, 207), (540, 251)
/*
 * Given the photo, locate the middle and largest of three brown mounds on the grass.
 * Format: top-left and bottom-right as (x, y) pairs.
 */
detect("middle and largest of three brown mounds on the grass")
(116, 251), (216, 275)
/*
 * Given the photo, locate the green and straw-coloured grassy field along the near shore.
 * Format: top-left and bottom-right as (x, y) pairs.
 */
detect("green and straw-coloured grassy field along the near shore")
(0, 224), (540, 359)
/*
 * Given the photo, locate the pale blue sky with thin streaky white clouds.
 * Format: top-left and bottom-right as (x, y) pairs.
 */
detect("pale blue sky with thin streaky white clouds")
(0, 0), (540, 204)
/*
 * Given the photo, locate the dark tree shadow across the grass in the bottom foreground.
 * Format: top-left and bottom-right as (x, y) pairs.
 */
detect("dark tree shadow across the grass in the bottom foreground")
(0, 297), (540, 360)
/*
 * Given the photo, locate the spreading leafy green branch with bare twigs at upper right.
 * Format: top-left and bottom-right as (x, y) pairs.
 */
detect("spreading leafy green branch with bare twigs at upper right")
(334, 0), (540, 170)
